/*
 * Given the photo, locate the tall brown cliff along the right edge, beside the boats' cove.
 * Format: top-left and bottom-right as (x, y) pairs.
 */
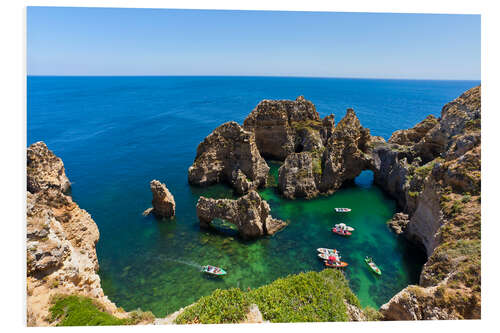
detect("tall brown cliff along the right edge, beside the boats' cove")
(373, 87), (481, 320)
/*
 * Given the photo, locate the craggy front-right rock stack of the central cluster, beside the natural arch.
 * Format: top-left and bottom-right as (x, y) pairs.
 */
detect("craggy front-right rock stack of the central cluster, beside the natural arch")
(264, 104), (372, 199)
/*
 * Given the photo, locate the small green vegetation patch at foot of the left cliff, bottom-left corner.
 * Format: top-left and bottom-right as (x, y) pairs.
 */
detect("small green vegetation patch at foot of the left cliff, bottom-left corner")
(49, 295), (155, 326)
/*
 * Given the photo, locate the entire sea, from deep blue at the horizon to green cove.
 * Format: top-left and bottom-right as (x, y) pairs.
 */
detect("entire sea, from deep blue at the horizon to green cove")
(27, 77), (479, 316)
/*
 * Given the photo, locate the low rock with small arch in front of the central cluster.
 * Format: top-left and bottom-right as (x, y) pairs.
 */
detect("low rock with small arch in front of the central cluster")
(196, 190), (286, 238)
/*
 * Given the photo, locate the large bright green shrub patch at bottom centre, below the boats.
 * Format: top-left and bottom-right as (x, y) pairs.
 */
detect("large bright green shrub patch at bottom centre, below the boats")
(176, 269), (360, 324)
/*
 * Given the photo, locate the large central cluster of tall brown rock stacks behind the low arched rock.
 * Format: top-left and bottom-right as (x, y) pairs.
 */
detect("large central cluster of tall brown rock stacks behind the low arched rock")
(189, 96), (379, 199)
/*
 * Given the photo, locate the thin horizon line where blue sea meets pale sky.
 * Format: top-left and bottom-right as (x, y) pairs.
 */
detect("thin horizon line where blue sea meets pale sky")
(26, 74), (481, 81)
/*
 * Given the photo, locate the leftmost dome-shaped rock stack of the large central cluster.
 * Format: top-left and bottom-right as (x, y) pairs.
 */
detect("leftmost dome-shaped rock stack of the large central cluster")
(188, 121), (269, 194)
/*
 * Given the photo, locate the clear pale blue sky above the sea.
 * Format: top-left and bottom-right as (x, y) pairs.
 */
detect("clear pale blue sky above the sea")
(27, 7), (481, 80)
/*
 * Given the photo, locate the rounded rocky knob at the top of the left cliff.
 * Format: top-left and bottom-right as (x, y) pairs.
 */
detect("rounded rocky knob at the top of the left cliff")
(26, 141), (71, 193)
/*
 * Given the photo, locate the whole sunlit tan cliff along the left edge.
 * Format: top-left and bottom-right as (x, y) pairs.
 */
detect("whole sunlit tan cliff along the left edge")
(26, 142), (124, 326)
